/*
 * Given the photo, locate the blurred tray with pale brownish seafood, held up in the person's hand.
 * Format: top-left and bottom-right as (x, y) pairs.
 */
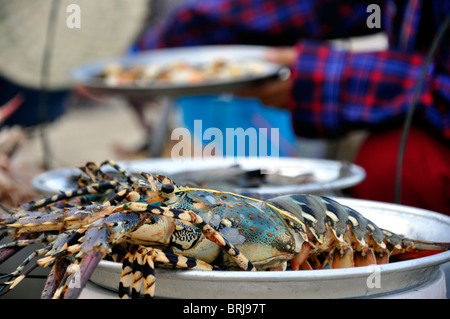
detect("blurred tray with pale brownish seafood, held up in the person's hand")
(72, 45), (289, 96)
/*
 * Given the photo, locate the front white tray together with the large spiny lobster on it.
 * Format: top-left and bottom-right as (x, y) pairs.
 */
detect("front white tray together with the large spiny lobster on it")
(0, 160), (450, 299)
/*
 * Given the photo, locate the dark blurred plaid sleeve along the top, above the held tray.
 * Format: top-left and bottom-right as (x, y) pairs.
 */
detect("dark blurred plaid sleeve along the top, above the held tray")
(138, 0), (382, 50)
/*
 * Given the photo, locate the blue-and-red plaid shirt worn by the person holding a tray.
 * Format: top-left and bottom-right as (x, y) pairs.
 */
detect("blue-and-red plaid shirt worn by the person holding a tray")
(138, 0), (450, 142)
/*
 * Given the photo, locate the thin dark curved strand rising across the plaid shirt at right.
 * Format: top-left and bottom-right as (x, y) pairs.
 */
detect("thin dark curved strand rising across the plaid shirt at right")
(394, 14), (450, 204)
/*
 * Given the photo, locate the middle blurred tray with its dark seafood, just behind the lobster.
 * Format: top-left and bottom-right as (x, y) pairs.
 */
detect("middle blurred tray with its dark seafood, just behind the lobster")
(32, 157), (365, 199)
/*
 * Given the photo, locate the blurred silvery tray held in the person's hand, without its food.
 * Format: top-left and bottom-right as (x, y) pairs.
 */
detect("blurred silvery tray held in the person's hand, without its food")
(71, 45), (290, 96)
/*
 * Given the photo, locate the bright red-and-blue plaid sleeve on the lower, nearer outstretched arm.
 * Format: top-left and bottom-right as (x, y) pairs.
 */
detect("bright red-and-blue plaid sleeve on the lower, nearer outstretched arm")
(289, 40), (450, 138)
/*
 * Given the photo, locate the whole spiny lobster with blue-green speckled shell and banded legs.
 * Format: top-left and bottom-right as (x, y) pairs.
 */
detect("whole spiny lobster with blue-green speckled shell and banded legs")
(0, 161), (450, 298)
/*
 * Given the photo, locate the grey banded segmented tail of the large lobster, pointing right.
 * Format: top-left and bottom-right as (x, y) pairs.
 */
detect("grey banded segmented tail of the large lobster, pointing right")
(269, 195), (450, 269)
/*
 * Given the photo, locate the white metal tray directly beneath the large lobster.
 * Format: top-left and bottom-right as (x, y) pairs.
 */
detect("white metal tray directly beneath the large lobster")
(91, 198), (450, 299)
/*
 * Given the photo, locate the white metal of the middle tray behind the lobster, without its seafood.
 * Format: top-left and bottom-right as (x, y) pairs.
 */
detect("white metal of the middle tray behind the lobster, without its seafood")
(32, 157), (366, 199)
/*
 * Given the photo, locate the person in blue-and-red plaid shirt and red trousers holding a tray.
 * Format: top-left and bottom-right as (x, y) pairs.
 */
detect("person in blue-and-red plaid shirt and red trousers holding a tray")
(138, 0), (450, 214)
